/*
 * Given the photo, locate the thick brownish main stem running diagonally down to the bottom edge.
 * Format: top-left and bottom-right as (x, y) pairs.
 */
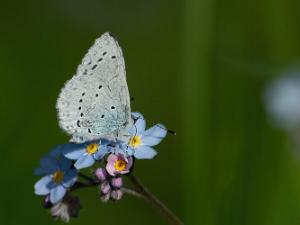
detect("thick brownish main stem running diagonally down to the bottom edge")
(129, 174), (183, 225)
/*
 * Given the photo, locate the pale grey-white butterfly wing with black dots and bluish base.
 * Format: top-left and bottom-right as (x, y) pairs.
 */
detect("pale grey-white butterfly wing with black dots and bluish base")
(57, 33), (132, 143)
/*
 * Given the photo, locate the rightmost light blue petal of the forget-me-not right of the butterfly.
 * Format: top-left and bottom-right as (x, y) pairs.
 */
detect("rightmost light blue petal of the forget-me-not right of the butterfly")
(142, 124), (167, 146)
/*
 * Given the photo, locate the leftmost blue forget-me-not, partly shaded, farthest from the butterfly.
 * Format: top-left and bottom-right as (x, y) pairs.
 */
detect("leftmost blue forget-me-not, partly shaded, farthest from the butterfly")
(34, 145), (77, 204)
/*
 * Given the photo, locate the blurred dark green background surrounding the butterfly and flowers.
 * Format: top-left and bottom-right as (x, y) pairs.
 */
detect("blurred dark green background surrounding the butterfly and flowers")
(0, 0), (300, 225)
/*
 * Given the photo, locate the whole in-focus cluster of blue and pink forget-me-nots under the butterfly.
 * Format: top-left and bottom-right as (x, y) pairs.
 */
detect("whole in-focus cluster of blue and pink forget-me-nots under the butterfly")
(34, 113), (167, 222)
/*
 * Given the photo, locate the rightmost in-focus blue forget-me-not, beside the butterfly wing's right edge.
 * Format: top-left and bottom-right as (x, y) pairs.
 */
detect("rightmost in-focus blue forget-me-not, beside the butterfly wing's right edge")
(128, 112), (167, 159)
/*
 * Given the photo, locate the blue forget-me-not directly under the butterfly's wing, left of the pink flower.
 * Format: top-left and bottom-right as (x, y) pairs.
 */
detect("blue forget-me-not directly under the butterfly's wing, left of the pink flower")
(63, 140), (109, 169)
